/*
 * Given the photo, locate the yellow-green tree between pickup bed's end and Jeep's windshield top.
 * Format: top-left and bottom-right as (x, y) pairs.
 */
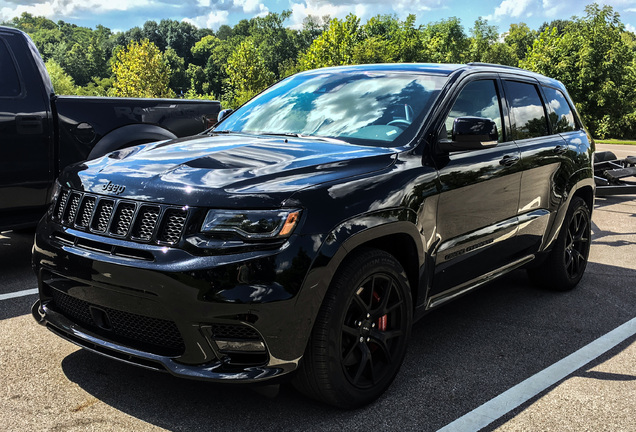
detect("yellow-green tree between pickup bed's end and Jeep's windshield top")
(226, 39), (274, 107)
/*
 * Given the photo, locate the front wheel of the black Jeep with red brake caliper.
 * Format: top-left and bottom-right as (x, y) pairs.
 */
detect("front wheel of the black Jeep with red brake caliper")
(293, 249), (413, 409)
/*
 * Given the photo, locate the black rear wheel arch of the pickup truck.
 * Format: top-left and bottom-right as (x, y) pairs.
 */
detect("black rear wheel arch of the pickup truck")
(87, 124), (177, 159)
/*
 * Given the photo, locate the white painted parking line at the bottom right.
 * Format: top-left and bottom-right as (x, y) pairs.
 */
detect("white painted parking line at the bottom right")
(438, 318), (636, 432)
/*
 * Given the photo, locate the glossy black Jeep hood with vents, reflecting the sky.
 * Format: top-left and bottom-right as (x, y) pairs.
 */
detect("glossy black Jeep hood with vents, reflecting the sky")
(62, 134), (397, 208)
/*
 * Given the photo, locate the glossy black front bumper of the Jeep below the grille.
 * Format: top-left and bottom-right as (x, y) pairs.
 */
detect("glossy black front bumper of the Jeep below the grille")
(32, 221), (320, 382)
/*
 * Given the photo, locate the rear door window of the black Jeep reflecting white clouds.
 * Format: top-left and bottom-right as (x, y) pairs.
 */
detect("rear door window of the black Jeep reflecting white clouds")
(504, 81), (548, 140)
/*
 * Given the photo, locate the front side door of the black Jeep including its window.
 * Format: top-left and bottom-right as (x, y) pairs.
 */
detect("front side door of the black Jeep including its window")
(430, 74), (521, 298)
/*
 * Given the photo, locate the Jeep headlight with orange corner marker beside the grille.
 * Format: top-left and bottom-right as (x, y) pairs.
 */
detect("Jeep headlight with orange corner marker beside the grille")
(201, 209), (300, 239)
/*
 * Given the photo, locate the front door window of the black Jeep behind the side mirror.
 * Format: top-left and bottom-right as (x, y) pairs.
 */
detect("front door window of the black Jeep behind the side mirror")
(445, 80), (503, 142)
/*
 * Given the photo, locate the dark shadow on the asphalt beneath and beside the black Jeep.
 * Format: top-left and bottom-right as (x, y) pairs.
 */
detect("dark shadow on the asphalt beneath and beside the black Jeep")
(62, 262), (636, 431)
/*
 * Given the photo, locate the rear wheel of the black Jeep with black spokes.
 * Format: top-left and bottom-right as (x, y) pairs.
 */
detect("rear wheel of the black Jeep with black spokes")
(528, 197), (592, 291)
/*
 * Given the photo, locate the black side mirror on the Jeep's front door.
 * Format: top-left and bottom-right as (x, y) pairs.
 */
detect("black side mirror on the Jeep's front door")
(439, 117), (499, 152)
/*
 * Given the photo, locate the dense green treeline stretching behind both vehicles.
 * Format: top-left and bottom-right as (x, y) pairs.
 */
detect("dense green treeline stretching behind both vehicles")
(2, 4), (636, 138)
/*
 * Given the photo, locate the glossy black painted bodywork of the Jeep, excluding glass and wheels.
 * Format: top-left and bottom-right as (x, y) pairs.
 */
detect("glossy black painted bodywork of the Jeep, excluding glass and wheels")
(33, 65), (594, 382)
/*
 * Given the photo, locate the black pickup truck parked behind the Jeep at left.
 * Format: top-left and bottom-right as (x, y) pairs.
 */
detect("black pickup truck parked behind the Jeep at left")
(0, 27), (220, 230)
